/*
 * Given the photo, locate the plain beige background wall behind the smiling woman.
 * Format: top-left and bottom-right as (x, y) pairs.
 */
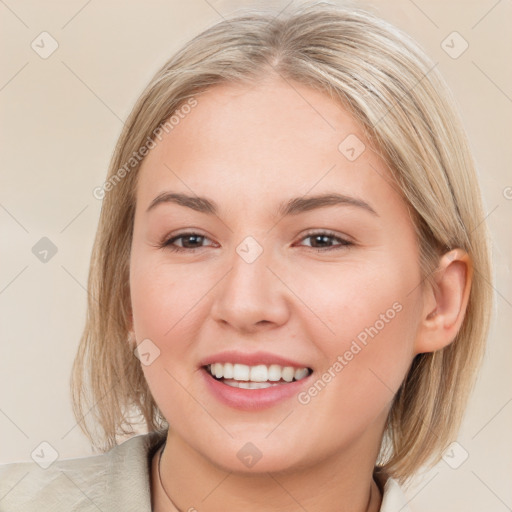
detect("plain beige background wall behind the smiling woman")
(0, 0), (512, 512)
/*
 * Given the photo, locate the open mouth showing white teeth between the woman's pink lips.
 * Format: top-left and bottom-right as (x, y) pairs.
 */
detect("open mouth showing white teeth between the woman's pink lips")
(203, 363), (313, 389)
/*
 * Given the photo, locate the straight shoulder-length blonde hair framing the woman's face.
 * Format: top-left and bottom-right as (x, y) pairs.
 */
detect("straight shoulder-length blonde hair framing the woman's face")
(72, 2), (492, 482)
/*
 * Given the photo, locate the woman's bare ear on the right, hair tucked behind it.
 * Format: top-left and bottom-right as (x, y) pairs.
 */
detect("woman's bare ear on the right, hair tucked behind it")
(414, 249), (473, 354)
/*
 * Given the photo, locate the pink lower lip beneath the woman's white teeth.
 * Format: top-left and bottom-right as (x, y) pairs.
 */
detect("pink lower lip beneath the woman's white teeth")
(201, 368), (312, 411)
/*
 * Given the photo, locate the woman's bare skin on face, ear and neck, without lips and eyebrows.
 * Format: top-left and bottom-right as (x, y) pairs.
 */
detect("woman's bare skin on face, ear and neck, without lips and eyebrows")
(130, 73), (471, 512)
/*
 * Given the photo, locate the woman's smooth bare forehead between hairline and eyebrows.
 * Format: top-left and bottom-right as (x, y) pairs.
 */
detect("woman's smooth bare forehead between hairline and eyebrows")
(137, 78), (404, 215)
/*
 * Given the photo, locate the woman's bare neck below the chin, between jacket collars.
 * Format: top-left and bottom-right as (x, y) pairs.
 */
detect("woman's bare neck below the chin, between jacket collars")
(152, 430), (382, 512)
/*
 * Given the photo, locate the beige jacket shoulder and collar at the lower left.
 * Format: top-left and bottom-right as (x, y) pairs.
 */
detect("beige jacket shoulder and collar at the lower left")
(0, 432), (165, 512)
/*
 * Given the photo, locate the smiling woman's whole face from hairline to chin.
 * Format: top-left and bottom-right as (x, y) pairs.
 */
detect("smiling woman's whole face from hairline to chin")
(130, 75), (423, 471)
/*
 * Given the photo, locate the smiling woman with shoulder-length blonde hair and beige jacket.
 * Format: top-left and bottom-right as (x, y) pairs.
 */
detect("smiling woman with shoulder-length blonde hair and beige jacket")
(0, 4), (491, 512)
